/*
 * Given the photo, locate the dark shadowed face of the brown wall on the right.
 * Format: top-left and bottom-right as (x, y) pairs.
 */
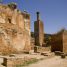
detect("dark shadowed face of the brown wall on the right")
(51, 33), (63, 52)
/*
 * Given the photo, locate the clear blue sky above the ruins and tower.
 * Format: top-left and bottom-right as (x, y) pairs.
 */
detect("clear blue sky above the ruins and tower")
(3, 0), (67, 33)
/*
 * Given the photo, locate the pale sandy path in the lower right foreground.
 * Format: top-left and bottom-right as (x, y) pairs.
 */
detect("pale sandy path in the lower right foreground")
(26, 56), (67, 67)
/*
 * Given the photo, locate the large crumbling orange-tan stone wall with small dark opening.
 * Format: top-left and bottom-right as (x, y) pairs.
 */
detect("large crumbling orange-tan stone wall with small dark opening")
(0, 4), (30, 53)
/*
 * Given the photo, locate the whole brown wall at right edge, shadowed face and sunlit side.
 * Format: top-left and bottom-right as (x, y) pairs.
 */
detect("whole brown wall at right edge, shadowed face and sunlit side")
(51, 30), (67, 53)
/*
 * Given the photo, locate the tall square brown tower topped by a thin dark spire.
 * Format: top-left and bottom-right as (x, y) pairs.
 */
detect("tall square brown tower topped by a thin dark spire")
(34, 12), (44, 46)
